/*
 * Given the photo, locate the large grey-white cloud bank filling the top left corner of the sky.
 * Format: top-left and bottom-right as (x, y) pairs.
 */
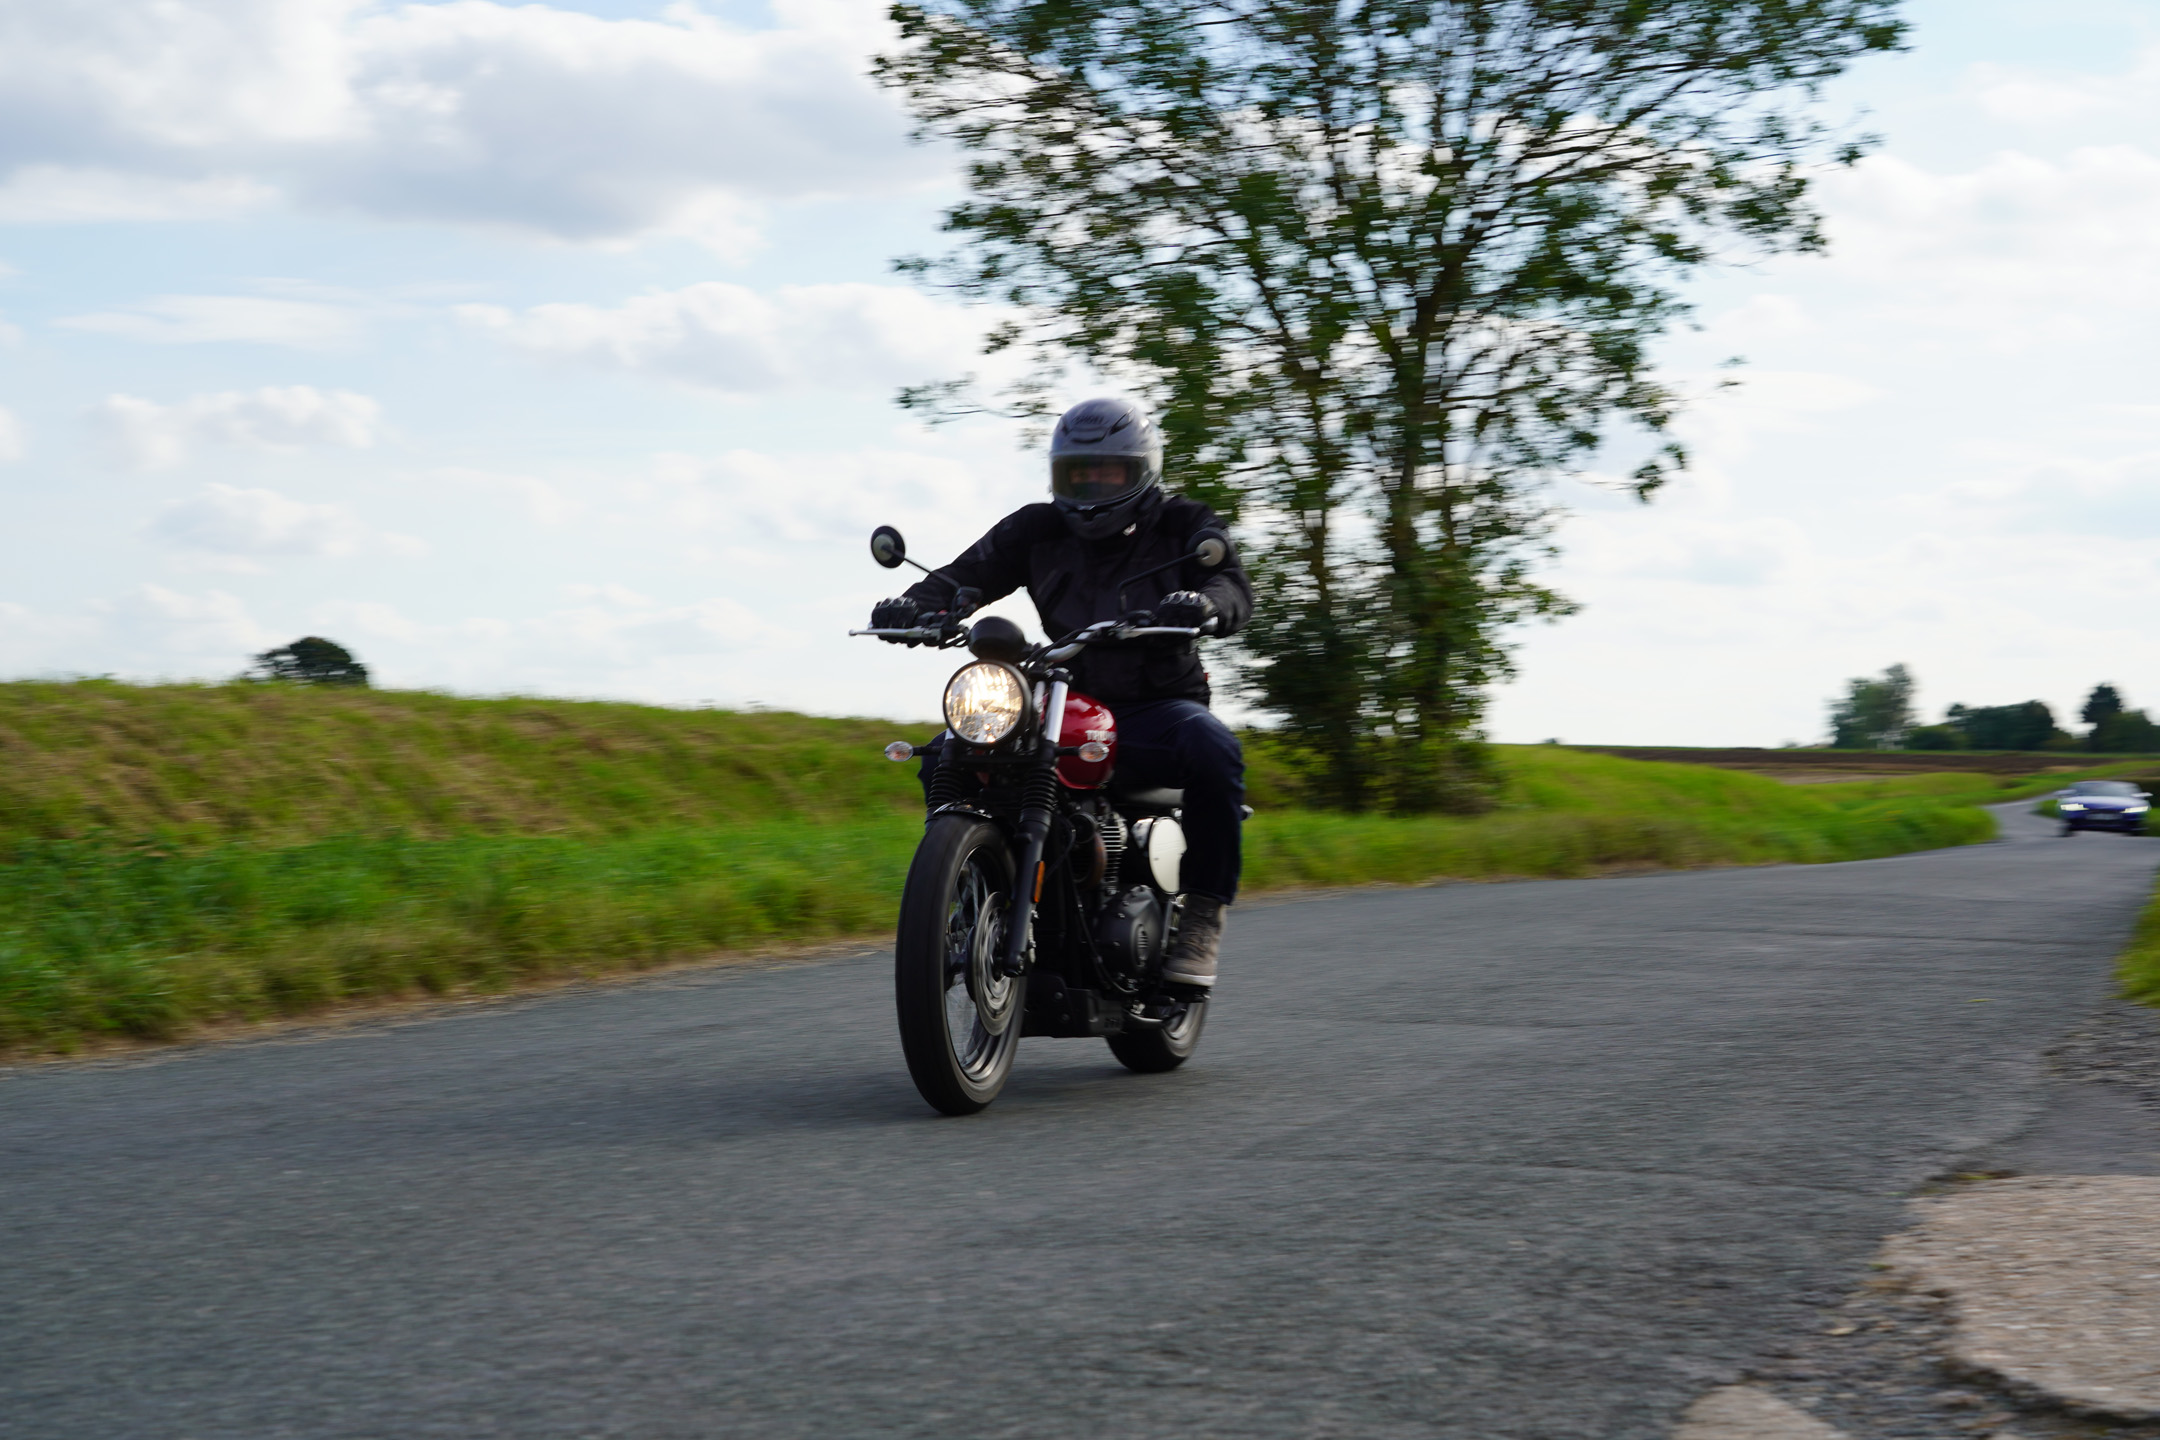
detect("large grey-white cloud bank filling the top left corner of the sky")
(0, 0), (937, 244)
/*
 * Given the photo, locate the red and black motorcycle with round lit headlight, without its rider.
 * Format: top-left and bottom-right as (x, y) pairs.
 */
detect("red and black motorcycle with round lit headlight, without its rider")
(849, 525), (1251, 1114)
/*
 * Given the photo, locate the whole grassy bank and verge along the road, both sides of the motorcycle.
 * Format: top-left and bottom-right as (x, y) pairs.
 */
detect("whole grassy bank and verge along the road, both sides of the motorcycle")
(0, 682), (2125, 1049)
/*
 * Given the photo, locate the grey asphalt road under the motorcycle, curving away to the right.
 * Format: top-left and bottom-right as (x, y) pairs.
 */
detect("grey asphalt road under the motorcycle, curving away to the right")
(0, 816), (2160, 1440)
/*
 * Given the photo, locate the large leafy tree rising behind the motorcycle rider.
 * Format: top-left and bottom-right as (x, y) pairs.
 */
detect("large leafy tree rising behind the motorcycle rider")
(879, 0), (1901, 810)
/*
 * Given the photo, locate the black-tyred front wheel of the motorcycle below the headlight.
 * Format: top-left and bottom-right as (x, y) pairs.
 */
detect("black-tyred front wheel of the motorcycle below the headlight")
(892, 814), (1028, 1114)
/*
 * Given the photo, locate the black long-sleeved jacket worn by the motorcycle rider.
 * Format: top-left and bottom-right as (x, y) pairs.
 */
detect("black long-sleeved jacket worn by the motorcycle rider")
(907, 490), (1253, 704)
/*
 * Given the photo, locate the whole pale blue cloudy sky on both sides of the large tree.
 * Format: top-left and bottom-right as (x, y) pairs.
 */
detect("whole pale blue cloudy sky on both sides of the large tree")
(0, 0), (2160, 745)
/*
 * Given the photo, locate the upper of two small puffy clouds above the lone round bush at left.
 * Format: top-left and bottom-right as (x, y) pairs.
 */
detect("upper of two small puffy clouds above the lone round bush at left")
(91, 384), (382, 471)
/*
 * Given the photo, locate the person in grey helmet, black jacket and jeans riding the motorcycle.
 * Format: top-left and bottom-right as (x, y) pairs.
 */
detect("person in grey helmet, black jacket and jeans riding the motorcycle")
(870, 399), (1253, 987)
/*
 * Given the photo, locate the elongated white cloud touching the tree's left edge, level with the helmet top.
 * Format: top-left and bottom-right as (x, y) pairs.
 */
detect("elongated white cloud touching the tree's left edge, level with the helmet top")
(458, 281), (985, 395)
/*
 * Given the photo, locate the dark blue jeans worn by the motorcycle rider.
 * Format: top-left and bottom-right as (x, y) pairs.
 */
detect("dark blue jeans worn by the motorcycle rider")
(922, 699), (1244, 905)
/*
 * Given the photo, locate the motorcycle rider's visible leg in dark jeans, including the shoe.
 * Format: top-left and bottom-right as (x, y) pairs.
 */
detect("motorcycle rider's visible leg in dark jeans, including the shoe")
(1115, 699), (1244, 984)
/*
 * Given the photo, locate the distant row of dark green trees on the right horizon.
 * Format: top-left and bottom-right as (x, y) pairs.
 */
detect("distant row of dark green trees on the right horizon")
(1830, 665), (2160, 756)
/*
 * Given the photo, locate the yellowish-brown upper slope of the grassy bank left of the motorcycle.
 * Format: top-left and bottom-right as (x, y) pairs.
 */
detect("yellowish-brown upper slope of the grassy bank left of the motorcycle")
(0, 680), (933, 844)
